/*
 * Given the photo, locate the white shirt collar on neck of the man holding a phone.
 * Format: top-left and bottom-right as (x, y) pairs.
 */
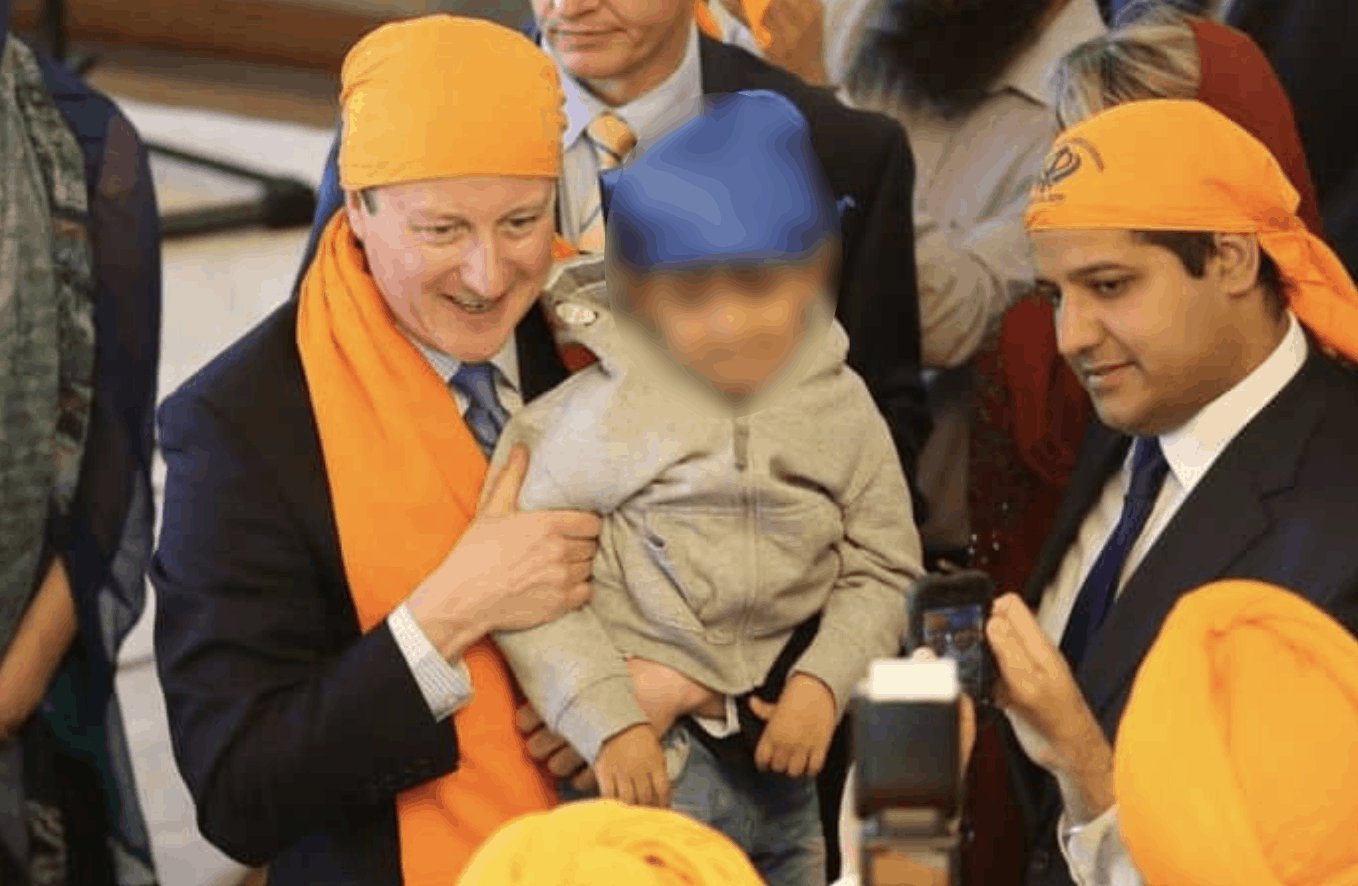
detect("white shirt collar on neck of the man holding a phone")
(1160, 311), (1309, 491)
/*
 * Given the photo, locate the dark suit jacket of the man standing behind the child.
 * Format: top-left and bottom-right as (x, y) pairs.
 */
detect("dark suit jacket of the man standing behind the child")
(299, 37), (930, 502)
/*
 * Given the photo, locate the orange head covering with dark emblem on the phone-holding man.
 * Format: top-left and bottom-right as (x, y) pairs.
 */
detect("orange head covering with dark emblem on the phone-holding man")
(1024, 99), (1358, 360)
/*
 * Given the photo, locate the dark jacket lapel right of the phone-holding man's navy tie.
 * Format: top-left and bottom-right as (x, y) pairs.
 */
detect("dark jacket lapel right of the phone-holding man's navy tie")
(1076, 355), (1324, 737)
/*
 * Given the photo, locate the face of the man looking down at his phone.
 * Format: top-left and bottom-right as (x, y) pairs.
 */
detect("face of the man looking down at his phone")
(1032, 231), (1249, 436)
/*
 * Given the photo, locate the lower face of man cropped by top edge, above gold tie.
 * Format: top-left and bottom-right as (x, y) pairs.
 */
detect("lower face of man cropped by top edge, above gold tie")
(532, 0), (693, 105)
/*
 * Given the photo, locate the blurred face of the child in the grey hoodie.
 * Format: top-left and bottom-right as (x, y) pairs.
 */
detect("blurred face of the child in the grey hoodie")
(634, 259), (826, 400)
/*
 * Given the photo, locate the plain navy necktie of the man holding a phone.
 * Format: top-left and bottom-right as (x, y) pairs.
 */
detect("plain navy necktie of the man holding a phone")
(1061, 436), (1169, 667)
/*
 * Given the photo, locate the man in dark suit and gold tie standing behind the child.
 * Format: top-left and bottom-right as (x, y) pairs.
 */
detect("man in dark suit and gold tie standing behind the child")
(303, 6), (930, 879)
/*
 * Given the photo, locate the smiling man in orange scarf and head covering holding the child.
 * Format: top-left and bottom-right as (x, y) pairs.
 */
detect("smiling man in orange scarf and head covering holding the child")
(152, 15), (598, 886)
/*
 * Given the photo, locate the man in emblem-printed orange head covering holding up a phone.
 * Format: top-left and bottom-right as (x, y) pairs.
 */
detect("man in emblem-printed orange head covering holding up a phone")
(987, 101), (1358, 885)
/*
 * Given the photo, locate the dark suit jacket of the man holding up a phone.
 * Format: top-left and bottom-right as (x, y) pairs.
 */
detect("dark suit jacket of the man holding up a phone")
(1009, 344), (1358, 886)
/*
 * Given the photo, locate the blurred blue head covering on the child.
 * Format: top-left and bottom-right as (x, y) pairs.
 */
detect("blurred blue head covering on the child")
(602, 90), (839, 273)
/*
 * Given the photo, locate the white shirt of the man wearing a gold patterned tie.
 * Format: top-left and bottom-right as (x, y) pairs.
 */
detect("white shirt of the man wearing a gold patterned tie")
(551, 25), (720, 243)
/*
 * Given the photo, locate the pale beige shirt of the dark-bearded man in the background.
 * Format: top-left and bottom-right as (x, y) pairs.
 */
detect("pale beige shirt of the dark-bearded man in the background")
(832, 0), (1107, 368)
